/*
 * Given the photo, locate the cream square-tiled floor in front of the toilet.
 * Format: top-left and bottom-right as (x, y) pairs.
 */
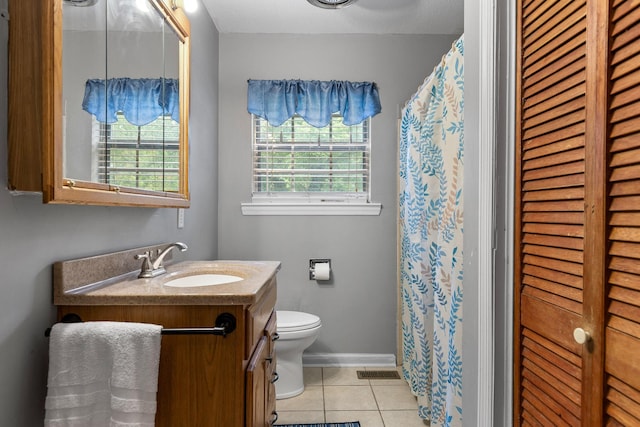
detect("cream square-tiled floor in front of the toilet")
(276, 368), (428, 427)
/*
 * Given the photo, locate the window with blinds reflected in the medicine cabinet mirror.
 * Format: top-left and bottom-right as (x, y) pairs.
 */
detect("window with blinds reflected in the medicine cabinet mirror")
(94, 112), (180, 192)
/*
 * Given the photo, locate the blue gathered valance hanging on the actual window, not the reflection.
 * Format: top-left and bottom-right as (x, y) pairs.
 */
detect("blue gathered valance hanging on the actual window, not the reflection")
(247, 80), (382, 127)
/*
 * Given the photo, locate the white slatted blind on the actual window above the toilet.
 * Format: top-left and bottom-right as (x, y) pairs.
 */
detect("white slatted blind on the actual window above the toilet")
(252, 114), (370, 203)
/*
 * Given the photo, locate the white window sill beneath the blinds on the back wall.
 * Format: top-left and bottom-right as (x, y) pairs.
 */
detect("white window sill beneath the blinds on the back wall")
(242, 202), (382, 216)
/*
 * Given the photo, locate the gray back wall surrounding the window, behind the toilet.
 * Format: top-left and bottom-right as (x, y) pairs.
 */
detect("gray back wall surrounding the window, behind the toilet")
(218, 34), (457, 354)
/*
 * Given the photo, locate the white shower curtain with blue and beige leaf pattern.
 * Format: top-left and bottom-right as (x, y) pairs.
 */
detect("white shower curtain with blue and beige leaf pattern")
(399, 37), (464, 426)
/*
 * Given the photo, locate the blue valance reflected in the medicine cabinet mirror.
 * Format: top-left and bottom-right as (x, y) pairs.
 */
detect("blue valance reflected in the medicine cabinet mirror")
(82, 77), (180, 126)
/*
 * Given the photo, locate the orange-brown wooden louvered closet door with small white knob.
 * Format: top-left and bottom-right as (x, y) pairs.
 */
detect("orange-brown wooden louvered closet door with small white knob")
(514, 0), (640, 426)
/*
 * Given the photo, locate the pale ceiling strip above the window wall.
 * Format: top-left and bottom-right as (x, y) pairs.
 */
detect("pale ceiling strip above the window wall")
(202, 0), (464, 34)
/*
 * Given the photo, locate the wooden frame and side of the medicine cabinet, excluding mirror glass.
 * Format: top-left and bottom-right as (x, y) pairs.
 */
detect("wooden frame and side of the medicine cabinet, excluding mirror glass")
(7, 0), (190, 207)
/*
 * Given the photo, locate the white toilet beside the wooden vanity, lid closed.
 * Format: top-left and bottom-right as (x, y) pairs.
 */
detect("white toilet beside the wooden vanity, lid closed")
(275, 310), (322, 399)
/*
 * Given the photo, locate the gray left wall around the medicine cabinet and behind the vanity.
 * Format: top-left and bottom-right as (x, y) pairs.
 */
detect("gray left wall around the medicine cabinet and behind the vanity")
(0, 0), (218, 426)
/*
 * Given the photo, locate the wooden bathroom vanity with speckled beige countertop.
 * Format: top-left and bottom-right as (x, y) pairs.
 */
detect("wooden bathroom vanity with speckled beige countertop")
(54, 252), (280, 427)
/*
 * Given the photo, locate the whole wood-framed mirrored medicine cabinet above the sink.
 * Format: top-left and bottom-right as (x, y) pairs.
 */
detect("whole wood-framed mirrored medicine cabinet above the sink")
(8, 0), (190, 207)
